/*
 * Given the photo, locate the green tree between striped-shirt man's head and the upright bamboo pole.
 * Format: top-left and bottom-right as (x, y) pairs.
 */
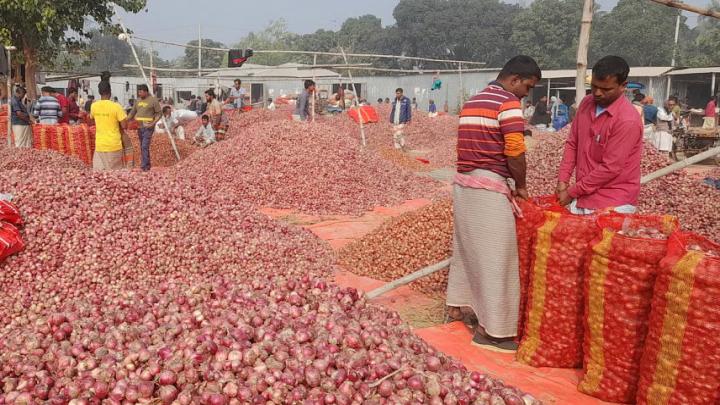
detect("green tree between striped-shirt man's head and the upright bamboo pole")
(510, 0), (583, 69)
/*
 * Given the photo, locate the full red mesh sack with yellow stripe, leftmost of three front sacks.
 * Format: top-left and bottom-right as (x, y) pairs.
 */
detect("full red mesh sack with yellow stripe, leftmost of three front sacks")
(517, 196), (599, 368)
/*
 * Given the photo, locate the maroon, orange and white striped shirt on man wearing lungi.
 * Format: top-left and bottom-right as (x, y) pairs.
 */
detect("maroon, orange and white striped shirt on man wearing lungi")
(457, 82), (526, 177)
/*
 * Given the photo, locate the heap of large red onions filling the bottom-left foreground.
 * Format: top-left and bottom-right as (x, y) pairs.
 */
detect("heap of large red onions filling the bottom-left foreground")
(0, 277), (539, 405)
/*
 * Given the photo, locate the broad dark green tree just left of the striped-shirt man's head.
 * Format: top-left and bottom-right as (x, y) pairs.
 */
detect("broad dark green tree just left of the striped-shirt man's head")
(393, 0), (520, 68)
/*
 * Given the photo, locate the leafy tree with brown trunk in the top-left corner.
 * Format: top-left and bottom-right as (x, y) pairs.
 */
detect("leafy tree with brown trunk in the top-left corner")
(0, 0), (146, 98)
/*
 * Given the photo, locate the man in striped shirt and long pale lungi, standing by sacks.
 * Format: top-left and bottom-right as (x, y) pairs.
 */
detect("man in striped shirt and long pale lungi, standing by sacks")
(447, 55), (542, 352)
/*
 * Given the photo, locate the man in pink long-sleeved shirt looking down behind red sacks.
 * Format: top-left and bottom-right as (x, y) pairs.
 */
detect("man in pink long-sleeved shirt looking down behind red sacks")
(556, 56), (644, 214)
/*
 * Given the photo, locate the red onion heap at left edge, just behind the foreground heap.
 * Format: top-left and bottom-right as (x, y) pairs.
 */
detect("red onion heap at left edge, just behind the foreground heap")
(0, 169), (334, 328)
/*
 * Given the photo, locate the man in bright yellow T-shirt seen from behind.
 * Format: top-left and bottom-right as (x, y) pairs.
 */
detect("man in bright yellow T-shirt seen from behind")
(90, 82), (127, 170)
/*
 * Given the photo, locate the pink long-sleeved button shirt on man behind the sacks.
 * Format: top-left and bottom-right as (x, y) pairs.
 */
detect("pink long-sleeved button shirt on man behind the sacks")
(558, 95), (644, 210)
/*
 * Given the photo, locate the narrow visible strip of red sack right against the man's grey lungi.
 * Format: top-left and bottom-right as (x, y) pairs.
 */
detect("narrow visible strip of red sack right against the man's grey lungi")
(515, 200), (545, 341)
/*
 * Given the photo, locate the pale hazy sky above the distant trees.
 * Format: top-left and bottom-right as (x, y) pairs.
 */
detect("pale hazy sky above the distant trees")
(121, 0), (709, 59)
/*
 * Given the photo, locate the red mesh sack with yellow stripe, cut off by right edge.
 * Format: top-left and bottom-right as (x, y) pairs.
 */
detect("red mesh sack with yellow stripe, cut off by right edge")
(637, 232), (720, 405)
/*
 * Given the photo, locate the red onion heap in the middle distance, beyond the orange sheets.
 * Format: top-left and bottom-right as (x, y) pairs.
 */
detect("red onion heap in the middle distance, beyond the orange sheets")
(174, 120), (440, 215)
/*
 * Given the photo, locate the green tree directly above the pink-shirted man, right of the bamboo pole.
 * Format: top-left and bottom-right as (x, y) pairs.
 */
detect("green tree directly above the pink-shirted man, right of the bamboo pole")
(590, 0), (689, 66)
